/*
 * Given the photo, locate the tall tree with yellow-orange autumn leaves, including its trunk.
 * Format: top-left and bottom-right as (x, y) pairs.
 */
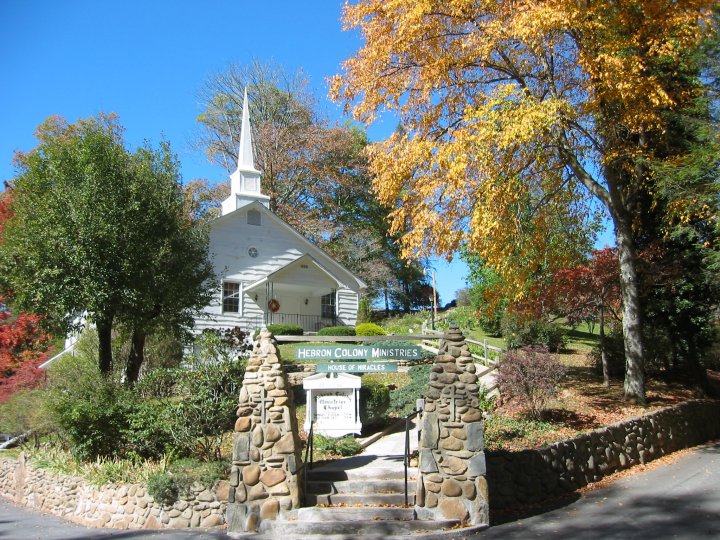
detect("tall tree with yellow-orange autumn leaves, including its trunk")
(331, 0), (714, 403)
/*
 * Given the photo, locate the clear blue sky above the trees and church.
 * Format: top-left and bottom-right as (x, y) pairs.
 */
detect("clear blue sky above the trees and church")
(0, 0), (612, 303)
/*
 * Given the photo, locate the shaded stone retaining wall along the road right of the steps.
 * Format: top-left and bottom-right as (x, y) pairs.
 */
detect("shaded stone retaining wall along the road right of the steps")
(486, 400), (720, 511)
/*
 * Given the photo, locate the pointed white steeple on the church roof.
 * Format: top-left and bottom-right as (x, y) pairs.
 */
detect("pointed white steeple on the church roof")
(222, 88), (270, 216)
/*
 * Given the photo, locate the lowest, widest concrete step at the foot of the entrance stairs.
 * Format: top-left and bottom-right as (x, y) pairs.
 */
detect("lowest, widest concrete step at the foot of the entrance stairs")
(259, 520), (458, 538)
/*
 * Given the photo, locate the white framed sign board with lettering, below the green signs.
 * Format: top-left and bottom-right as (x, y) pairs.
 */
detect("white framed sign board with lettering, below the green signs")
(303, 373), (362, 437)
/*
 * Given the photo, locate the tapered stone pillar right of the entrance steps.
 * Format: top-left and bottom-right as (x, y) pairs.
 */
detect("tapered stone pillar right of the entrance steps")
(415, 326), (489, 525)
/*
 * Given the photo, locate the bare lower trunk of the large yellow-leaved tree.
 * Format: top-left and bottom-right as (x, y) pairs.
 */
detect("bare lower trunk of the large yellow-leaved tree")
(613, 213), (645, 405)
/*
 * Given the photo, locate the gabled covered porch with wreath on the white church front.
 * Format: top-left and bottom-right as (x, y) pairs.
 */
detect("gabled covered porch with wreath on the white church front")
(245, 255), (341, 332)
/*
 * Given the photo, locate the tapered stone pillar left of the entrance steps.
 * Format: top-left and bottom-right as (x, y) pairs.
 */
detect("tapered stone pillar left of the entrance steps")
(227, 331), (301, 532)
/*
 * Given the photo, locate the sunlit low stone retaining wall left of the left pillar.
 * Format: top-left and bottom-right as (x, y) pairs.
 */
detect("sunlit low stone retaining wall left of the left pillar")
(0, 454), (228, 529)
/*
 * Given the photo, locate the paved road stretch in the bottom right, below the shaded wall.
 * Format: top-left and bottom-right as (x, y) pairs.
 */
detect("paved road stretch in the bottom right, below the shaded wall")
(473, 442), (720, 540)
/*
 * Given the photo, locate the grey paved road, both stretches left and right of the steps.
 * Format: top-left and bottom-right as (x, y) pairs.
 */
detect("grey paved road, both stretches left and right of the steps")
(0, 442), (720, 540)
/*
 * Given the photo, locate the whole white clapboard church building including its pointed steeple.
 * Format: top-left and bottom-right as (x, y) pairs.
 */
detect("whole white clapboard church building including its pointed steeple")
(195, 92), (365, 332)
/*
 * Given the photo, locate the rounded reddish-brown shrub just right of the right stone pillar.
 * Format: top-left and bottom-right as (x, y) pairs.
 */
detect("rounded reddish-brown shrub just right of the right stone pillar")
(496, 347), (567, 419)
